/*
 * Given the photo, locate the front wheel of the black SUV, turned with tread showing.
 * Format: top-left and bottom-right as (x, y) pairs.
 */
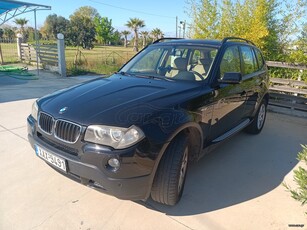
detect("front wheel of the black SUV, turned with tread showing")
(151, 134), (189, 205)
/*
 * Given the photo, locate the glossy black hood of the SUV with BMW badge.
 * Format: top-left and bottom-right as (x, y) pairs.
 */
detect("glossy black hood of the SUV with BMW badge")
(38, 74), (202, 127)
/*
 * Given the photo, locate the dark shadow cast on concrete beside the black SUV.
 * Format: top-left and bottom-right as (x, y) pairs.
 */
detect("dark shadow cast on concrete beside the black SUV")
(139, 120), (303, 216)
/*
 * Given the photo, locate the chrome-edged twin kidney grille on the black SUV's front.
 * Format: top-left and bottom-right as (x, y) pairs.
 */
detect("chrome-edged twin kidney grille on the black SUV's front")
(38, 112), (81, 144)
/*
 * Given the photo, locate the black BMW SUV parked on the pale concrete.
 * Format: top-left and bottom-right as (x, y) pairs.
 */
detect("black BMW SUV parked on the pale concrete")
(27, 37), (269, 205)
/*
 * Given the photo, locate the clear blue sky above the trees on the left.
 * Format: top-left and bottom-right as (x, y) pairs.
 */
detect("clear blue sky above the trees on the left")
(8, 0), (188, 36)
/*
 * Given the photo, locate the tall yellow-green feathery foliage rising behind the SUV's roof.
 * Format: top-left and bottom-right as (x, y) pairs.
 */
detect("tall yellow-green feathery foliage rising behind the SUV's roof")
(188, 0), (307, 60)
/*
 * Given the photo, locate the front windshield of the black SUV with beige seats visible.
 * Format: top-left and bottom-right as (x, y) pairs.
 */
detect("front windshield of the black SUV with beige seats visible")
(120, 45), (217, 81)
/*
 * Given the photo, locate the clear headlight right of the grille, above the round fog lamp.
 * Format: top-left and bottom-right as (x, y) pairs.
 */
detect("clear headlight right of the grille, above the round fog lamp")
(84, 125), (145, 149)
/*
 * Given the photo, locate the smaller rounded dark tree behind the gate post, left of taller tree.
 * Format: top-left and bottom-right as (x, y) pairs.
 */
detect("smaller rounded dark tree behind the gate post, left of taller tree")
(40, 14), (69, 39)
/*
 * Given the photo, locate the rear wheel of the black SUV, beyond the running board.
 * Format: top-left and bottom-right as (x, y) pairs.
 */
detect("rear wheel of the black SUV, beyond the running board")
(245, 100), (267, 134)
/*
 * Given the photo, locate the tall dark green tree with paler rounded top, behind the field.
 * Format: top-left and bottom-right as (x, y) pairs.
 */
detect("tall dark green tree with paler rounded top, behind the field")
(66, 6), (99, 49)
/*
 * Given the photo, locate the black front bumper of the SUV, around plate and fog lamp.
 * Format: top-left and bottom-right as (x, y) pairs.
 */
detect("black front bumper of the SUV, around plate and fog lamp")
(27, 116), (155, 200)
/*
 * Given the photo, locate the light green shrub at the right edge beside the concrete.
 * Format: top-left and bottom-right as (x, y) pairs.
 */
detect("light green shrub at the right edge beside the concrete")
(283, 145), (307, 214)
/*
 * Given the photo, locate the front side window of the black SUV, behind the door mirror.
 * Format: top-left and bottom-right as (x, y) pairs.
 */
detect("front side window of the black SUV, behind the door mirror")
(220, 46), (241, 79)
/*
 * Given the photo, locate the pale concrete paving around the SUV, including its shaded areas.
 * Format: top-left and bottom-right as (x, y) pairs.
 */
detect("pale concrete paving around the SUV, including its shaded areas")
(0, 71), (307, 230)
